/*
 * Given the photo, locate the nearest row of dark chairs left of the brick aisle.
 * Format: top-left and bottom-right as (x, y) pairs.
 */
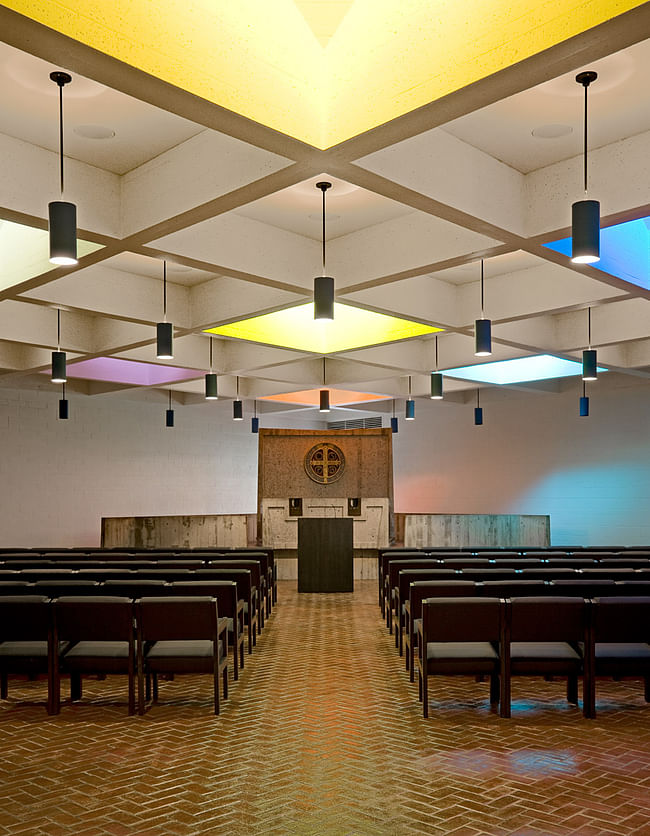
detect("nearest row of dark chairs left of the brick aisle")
(0, 595), (232, 714)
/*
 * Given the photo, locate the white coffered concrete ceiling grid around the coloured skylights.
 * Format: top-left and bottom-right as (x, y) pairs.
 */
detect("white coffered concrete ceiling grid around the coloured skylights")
(0, 3), (650, 422)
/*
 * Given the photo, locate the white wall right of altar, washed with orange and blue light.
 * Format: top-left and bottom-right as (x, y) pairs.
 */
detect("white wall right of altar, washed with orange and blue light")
(393, 376), (650, 546)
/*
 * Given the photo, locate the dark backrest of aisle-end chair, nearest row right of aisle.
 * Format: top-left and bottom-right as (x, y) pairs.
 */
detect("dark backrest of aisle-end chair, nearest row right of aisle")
(422, 598), (501, 642)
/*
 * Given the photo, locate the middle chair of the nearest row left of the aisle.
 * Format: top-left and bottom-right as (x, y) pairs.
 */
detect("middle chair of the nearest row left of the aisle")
(53, 595), (135, 714)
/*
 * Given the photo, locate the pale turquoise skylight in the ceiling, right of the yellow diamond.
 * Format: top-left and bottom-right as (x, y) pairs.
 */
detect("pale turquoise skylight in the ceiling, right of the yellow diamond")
(443, 354), (607, 385)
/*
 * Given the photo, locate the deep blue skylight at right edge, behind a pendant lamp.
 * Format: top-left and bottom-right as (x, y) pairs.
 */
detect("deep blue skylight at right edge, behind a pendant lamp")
(544, 218), (650, 290)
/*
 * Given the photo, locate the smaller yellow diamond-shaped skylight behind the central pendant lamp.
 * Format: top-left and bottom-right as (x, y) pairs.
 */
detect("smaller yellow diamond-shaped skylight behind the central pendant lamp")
(206, 302), (442, 354)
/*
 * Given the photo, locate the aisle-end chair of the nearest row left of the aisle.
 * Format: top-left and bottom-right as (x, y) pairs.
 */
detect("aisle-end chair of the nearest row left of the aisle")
(136, 595), (228, 714)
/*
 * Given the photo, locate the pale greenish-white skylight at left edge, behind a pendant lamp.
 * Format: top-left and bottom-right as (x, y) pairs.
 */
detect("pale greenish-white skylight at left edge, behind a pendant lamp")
(0, 220), (102, 290)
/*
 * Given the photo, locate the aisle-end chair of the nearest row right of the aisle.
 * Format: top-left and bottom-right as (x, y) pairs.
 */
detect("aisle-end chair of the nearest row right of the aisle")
(416, 598), (502, 717)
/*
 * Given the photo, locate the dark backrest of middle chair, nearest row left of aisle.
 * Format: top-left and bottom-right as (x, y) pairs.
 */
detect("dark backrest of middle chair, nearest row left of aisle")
(53, 595), (133, 641)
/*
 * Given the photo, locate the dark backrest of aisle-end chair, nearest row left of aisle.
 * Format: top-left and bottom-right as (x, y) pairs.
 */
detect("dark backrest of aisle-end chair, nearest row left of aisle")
(136, 595), (218, 641)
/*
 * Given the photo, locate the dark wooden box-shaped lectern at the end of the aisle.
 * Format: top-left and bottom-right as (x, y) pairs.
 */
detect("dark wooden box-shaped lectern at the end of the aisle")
(298, 517), (354, 592)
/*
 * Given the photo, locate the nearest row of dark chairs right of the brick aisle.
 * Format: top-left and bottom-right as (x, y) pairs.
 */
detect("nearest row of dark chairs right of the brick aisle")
(416, 596), (650, 718)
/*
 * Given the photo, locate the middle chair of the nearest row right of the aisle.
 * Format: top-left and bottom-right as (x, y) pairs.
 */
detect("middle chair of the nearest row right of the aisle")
(500, 596), (588, 717)
